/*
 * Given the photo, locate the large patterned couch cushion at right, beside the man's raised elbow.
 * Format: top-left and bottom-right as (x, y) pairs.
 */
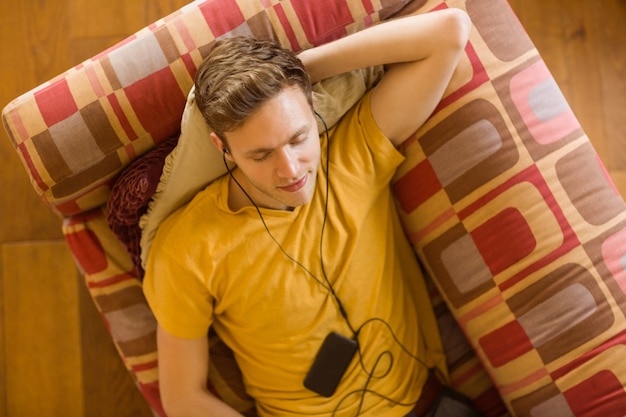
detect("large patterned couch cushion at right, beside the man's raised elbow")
(393, 0), (626, 416)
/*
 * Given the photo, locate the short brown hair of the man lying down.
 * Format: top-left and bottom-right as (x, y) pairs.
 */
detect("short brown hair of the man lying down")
(195, 36), (313, 141)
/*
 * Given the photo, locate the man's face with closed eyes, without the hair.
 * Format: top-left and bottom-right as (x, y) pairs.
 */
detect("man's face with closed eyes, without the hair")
(219, 87), (320, 210)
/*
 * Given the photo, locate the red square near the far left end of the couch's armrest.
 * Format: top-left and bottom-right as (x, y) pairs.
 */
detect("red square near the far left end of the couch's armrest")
(35, 78), (78, 127)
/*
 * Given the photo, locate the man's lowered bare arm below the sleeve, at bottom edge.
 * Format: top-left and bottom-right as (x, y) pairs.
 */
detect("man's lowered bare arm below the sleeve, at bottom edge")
(157, 326), (242, 417)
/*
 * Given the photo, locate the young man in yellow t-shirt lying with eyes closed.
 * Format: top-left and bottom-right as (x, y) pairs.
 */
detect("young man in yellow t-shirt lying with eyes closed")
(144, 10), (470, 417)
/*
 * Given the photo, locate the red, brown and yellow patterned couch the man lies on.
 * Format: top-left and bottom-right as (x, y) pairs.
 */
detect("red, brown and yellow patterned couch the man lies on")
(2, 0), (626, 417)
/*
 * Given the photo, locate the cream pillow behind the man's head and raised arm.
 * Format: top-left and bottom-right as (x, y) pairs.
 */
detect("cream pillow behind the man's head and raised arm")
(139, 66), (383, 268)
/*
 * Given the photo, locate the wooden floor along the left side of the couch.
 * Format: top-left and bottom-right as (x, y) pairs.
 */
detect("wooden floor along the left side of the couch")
(0, 0), (187, 417)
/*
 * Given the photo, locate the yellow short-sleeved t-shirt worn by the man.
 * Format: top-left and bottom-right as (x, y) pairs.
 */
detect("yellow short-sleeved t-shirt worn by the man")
(144, 94), (444, 417)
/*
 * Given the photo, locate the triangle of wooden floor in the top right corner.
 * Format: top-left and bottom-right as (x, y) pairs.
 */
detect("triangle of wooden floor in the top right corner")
(509, 0), (626, 196)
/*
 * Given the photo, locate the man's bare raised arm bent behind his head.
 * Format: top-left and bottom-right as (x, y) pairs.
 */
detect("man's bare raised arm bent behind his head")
(300, 9), (471, 145)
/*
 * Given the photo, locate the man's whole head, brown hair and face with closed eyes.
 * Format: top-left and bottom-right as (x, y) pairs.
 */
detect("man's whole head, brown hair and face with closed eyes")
(196, 37), (320, 209)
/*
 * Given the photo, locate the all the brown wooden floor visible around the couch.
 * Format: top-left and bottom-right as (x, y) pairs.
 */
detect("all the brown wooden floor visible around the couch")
(0, 0), (626, 417)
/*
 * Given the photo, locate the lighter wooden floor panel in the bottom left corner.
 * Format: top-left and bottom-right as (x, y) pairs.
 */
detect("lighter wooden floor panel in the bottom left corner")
(2, 241), (85, 417)
